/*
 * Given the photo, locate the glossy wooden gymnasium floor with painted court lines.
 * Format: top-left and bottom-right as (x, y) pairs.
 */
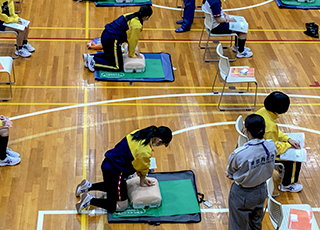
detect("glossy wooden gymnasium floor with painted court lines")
(0, 0), (320, 230)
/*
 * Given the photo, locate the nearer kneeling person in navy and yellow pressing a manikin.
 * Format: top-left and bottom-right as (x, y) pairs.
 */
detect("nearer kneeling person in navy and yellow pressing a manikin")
(75, 126), (172, 214)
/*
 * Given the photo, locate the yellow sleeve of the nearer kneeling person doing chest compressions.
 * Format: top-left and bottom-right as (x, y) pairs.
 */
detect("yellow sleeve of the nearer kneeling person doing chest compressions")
(127, 130), (153, 176)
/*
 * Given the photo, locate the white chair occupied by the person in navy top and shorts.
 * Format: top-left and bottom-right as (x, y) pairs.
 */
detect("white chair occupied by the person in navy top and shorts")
(199, 11), (238, 62)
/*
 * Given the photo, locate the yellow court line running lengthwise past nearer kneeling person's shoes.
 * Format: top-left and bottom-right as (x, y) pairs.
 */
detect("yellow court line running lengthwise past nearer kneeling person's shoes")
(81, 89), (89, 230)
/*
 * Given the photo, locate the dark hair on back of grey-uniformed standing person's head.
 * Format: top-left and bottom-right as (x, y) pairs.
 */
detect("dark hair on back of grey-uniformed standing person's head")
(244, 114), (266, 139)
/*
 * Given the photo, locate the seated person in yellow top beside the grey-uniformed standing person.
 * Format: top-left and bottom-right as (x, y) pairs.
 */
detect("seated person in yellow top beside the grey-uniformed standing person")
(256, 91), (303, 192)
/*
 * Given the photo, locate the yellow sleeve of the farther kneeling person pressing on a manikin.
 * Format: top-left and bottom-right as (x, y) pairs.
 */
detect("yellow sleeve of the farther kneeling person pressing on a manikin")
(127, 17), (142, 58)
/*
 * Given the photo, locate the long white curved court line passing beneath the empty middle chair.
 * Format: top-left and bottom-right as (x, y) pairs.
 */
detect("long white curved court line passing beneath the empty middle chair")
(10, 92), (320, 120)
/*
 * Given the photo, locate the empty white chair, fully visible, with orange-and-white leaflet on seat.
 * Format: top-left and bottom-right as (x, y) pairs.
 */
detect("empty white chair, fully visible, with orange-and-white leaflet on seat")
(212, 44), (258, 111)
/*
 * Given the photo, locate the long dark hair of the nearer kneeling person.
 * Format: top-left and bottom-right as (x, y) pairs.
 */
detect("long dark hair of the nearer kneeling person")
(131, 125), (172, 146)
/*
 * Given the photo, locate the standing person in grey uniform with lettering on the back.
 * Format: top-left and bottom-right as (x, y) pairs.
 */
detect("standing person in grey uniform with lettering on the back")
(226, 114), (277, 230)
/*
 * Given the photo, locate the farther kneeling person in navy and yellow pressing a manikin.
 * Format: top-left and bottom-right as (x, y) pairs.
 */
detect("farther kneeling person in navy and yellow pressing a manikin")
(83, 5), (153, 72)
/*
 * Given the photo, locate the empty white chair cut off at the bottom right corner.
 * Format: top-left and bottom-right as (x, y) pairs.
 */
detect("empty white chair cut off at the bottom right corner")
(267, 178), (319, 230)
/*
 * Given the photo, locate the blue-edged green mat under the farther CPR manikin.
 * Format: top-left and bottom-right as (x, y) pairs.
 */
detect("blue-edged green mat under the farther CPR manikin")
(94, 53), (174, 82)
